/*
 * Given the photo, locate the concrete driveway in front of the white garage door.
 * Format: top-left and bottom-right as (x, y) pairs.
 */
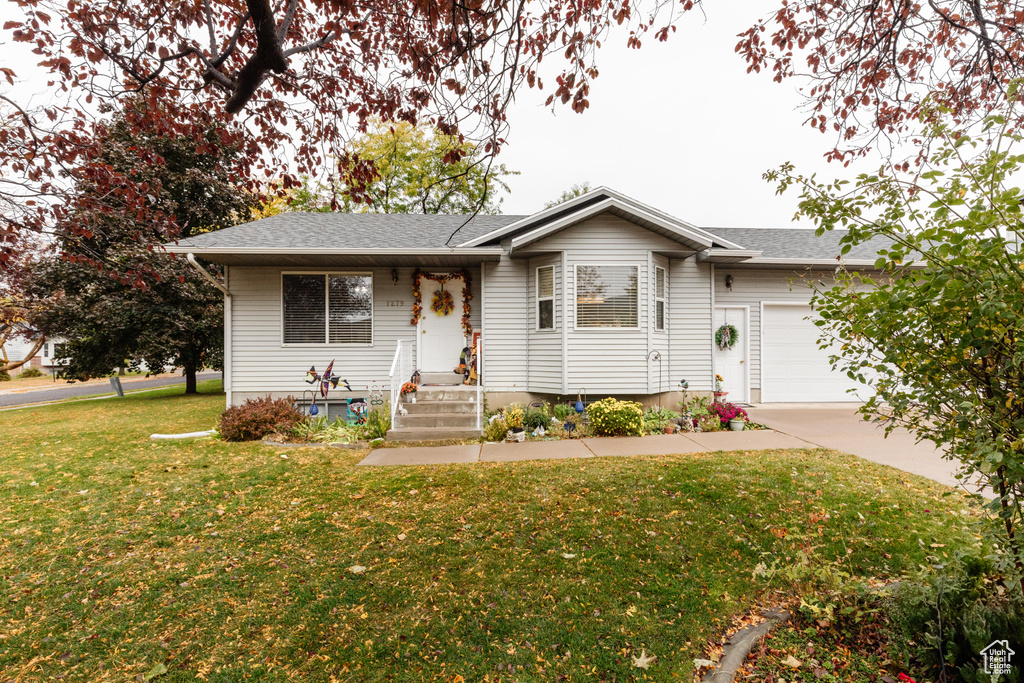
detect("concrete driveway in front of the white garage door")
(748, 403), (974, 493)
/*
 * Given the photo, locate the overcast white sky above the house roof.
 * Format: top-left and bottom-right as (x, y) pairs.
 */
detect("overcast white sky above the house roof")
(0, 0), (880, 227)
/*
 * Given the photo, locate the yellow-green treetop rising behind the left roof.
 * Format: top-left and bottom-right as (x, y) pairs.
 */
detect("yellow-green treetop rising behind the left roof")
(290, 121), (516, 214)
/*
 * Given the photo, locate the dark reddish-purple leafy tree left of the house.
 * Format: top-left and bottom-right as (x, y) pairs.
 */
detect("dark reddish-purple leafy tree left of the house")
(31, 100), (252, 392)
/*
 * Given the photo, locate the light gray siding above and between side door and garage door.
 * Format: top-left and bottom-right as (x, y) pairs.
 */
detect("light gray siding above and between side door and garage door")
(709, 265), (815, 389)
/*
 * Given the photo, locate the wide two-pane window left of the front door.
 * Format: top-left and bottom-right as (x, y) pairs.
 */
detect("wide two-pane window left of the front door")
(282, 273), (374, 344)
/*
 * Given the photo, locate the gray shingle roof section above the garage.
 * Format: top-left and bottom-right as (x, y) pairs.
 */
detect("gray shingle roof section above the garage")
(705, 227), (891, 261)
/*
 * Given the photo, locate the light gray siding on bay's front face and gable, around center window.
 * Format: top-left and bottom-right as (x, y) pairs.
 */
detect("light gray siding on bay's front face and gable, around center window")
(520, 214), (688, 397)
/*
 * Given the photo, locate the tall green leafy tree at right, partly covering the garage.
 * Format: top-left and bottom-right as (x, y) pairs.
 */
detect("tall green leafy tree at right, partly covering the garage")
(767, 98), (1024, 589)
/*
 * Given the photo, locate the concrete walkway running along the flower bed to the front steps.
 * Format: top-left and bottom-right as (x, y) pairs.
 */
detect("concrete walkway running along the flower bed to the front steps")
(359, 430), (808, 465)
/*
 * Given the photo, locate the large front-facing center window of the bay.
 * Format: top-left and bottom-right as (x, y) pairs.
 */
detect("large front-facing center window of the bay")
(575, 265), (639, 328)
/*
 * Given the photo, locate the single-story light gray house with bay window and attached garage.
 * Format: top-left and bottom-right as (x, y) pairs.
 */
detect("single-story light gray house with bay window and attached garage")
(168, 188), (888, 430)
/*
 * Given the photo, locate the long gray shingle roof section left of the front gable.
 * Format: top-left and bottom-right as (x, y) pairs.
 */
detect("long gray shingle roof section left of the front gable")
(172, 212), (522, 250)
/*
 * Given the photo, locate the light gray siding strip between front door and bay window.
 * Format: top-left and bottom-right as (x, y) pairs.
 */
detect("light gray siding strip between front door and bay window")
(483, 249), (530, 391)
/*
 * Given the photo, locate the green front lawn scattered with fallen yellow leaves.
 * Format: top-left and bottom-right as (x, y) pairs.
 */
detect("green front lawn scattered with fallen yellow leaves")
(0, 381), (974, 683)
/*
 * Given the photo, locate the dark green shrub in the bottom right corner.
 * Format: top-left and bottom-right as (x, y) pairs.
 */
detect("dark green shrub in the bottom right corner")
(887, 554), (1024, 683)
